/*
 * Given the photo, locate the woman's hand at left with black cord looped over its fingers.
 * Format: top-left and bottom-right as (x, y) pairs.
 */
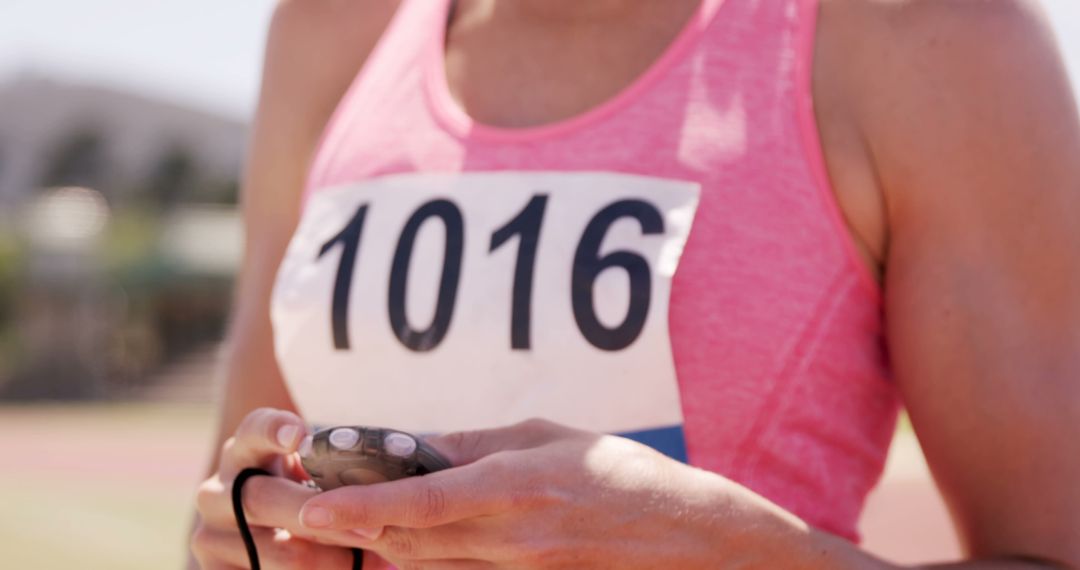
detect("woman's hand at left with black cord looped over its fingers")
(185, 408), (352, 570)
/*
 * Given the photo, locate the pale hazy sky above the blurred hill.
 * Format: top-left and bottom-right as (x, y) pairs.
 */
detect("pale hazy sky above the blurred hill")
(0, 0), (1080, 119)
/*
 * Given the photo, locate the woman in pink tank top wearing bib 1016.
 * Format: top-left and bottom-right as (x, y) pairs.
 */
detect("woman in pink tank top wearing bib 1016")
(192, 0), (1080, 569)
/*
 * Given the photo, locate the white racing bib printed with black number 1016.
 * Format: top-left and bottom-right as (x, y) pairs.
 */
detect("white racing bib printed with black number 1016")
(271, 172), (700, 461)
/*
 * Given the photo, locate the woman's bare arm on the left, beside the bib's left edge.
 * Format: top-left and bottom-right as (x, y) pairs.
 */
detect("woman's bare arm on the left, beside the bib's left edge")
(189, 0), (397, 565)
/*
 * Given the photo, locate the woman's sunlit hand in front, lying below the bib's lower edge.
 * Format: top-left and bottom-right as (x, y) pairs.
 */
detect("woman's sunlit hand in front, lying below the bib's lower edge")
(300, 420), (805, 569)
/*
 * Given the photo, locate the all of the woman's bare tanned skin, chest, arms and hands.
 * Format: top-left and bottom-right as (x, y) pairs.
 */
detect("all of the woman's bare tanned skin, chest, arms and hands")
(192, 0), (1080, 569)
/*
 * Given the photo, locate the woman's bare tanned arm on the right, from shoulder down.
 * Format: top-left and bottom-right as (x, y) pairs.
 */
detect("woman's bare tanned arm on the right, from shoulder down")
(826, 0), (1080, 568)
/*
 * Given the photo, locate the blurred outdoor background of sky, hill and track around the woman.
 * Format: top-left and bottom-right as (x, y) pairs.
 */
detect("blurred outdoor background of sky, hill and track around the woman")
(0, 0), (1080, 569)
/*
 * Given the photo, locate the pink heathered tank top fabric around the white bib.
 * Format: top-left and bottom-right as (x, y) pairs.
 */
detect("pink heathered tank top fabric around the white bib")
(308, 0), (897, 539)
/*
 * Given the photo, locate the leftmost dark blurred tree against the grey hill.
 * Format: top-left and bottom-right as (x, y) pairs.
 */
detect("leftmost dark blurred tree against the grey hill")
(39, 126), (108, 191)
